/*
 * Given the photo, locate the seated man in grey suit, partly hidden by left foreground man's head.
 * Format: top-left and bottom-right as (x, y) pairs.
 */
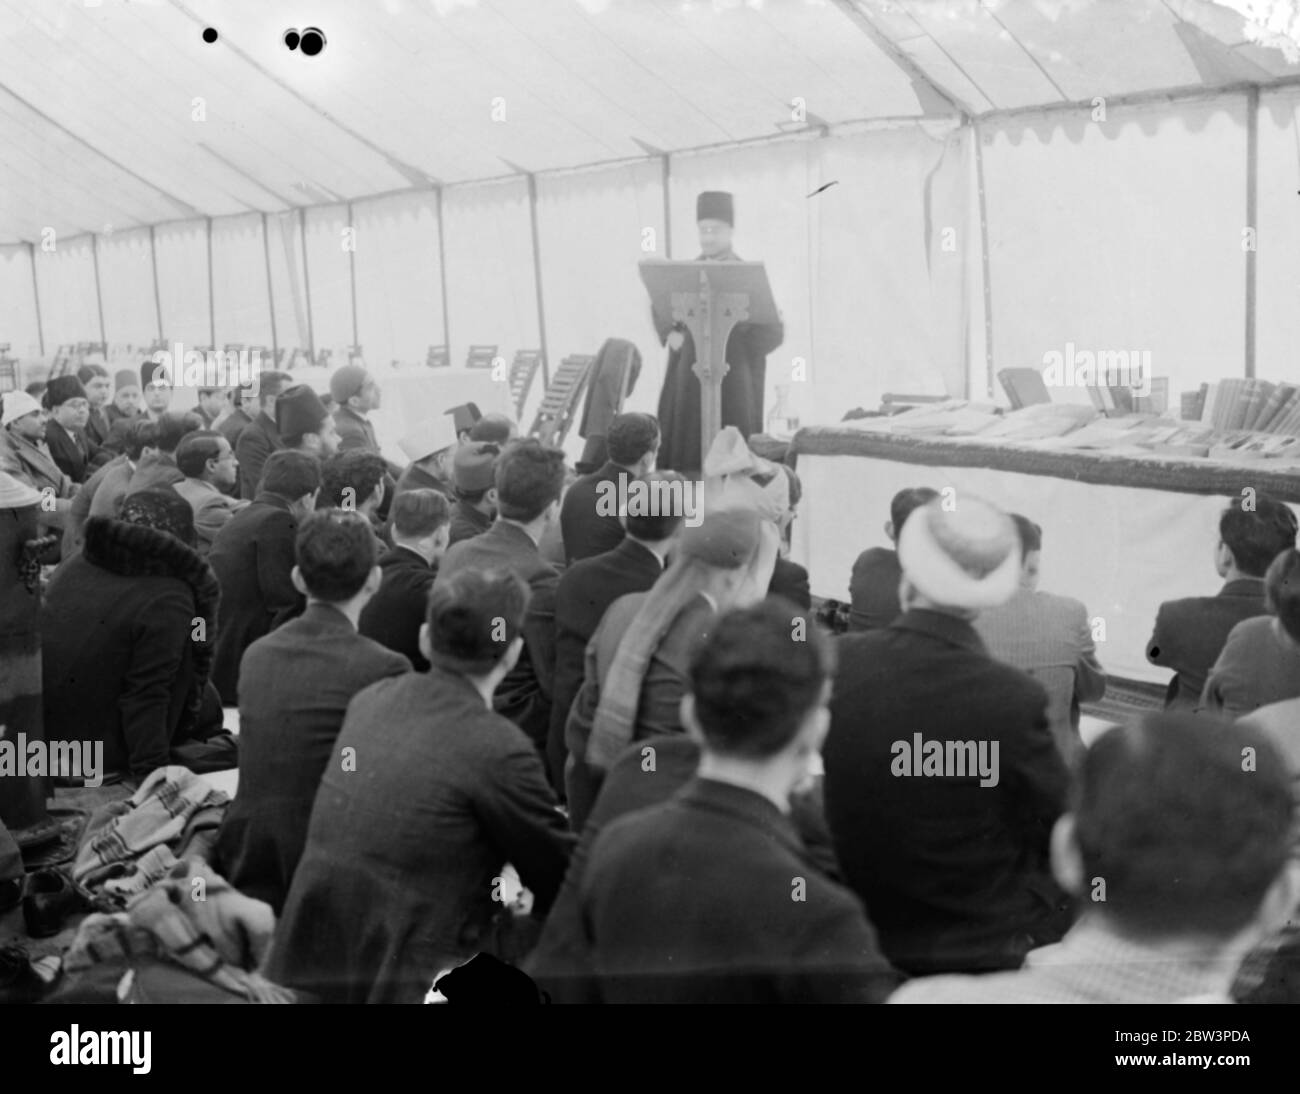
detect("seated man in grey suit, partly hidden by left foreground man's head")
(434, 438), (564, 755)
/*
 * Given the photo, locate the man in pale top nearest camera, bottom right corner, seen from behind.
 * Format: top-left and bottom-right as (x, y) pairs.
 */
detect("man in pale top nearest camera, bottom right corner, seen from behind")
(891, 713), (1300, 1003)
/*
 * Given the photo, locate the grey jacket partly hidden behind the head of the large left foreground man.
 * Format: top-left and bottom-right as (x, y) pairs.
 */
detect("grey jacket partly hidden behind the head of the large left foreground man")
(438, 520), (559, 754)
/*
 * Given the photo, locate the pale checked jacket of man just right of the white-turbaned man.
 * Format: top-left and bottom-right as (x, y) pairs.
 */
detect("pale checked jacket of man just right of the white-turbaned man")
(975, 589), (1106, 767)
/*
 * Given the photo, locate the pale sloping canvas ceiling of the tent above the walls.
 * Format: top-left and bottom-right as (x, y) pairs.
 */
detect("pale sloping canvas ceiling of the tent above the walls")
(0, 0), (1300, 242)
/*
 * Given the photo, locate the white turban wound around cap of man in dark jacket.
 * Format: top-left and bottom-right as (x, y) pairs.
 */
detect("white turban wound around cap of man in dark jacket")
(898, 496), (1021, 611)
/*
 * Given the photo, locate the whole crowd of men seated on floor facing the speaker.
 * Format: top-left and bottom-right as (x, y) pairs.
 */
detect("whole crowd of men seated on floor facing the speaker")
(0, 364), (1300, 1002)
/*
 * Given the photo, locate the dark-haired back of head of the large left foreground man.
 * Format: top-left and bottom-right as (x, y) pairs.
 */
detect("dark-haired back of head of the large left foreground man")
(426, 570), (529, 677)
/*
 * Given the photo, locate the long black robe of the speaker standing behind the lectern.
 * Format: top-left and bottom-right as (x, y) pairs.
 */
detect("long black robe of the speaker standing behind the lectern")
(651, 249), (785, 472)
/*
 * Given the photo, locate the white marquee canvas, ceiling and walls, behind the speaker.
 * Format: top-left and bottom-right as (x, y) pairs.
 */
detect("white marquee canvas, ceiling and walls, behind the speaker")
(0, 0), (1300, 422)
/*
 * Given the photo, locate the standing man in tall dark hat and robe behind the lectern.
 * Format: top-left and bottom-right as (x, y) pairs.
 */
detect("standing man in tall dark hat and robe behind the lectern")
(654, 190), (785, 472)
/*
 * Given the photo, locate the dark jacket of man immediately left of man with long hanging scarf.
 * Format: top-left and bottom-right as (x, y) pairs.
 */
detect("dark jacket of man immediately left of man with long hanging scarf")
(546, 535), (663, 786)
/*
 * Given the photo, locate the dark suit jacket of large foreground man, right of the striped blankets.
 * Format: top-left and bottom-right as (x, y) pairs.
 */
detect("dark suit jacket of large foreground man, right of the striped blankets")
(267, 668), (574, 1003)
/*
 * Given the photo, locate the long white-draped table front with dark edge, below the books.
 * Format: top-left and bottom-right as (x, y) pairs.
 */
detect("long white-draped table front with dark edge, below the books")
(792, 425), (1300, 683)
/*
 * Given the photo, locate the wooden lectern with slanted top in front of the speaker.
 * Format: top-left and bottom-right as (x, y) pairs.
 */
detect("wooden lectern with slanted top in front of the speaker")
(640, 259), (781, 460)
